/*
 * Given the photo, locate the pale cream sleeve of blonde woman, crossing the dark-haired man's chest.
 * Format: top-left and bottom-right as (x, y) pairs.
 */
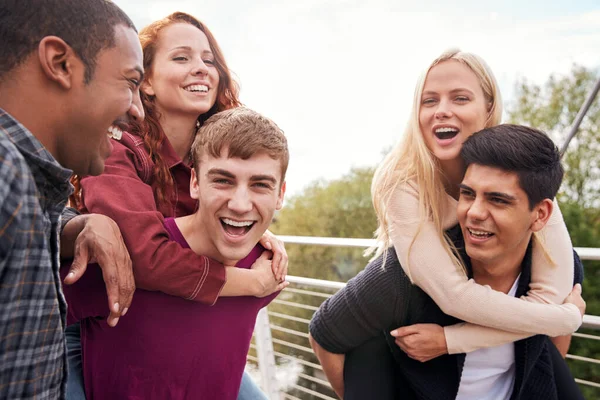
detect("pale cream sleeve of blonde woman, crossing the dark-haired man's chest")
(388, 184), (581, 354)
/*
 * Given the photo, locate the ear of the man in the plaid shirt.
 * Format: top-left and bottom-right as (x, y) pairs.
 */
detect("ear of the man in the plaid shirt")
(38, 36), (78, 90)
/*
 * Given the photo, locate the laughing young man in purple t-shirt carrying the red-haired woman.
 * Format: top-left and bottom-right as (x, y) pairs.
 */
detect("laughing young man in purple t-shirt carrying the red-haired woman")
(65, 108), (289, 400)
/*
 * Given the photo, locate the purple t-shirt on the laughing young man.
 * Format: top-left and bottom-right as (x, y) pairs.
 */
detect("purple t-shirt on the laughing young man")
(64, 218), (278, 400)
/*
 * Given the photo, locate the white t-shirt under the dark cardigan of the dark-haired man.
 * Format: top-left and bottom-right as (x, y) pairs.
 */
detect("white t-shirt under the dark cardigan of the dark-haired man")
(456, 275), (520, 400)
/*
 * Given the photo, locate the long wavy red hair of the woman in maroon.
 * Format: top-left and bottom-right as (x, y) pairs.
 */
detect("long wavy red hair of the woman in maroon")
(71, 12), (241, 208)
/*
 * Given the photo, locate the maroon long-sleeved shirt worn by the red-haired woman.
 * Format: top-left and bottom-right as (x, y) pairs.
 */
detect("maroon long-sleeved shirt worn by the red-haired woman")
(81, 132), (225, 304)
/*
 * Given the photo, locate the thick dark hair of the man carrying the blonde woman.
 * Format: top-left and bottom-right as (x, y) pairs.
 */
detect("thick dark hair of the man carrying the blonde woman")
(460, 124), (564, 209)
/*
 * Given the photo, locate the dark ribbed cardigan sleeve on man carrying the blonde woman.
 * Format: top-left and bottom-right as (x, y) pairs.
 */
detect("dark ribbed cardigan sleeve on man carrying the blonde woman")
(309, 257), (406, 354)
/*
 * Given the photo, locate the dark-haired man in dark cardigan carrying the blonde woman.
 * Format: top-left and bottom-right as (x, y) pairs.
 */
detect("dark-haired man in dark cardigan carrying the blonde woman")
(310, 125), (585, 400)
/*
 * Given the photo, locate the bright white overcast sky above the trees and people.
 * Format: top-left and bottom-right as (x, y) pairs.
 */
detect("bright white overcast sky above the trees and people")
(115, 0), (600, 194)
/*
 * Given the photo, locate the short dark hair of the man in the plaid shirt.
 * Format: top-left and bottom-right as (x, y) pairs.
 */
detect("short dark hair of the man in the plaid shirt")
(0, 0), (135, 83)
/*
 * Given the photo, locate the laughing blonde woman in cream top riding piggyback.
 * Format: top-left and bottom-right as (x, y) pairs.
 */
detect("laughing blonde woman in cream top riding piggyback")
(372, 50), (582, 361)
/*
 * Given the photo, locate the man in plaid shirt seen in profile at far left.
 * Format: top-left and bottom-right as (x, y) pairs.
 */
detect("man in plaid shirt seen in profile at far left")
(0, 0), (143, 399)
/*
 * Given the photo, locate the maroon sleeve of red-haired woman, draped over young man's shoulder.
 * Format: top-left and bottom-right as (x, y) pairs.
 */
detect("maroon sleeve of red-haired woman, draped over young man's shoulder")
(81, 141), (225, 304)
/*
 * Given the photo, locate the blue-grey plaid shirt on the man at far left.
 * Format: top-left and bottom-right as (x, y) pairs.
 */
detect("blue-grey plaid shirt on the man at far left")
(0, 109), (72, 399)
